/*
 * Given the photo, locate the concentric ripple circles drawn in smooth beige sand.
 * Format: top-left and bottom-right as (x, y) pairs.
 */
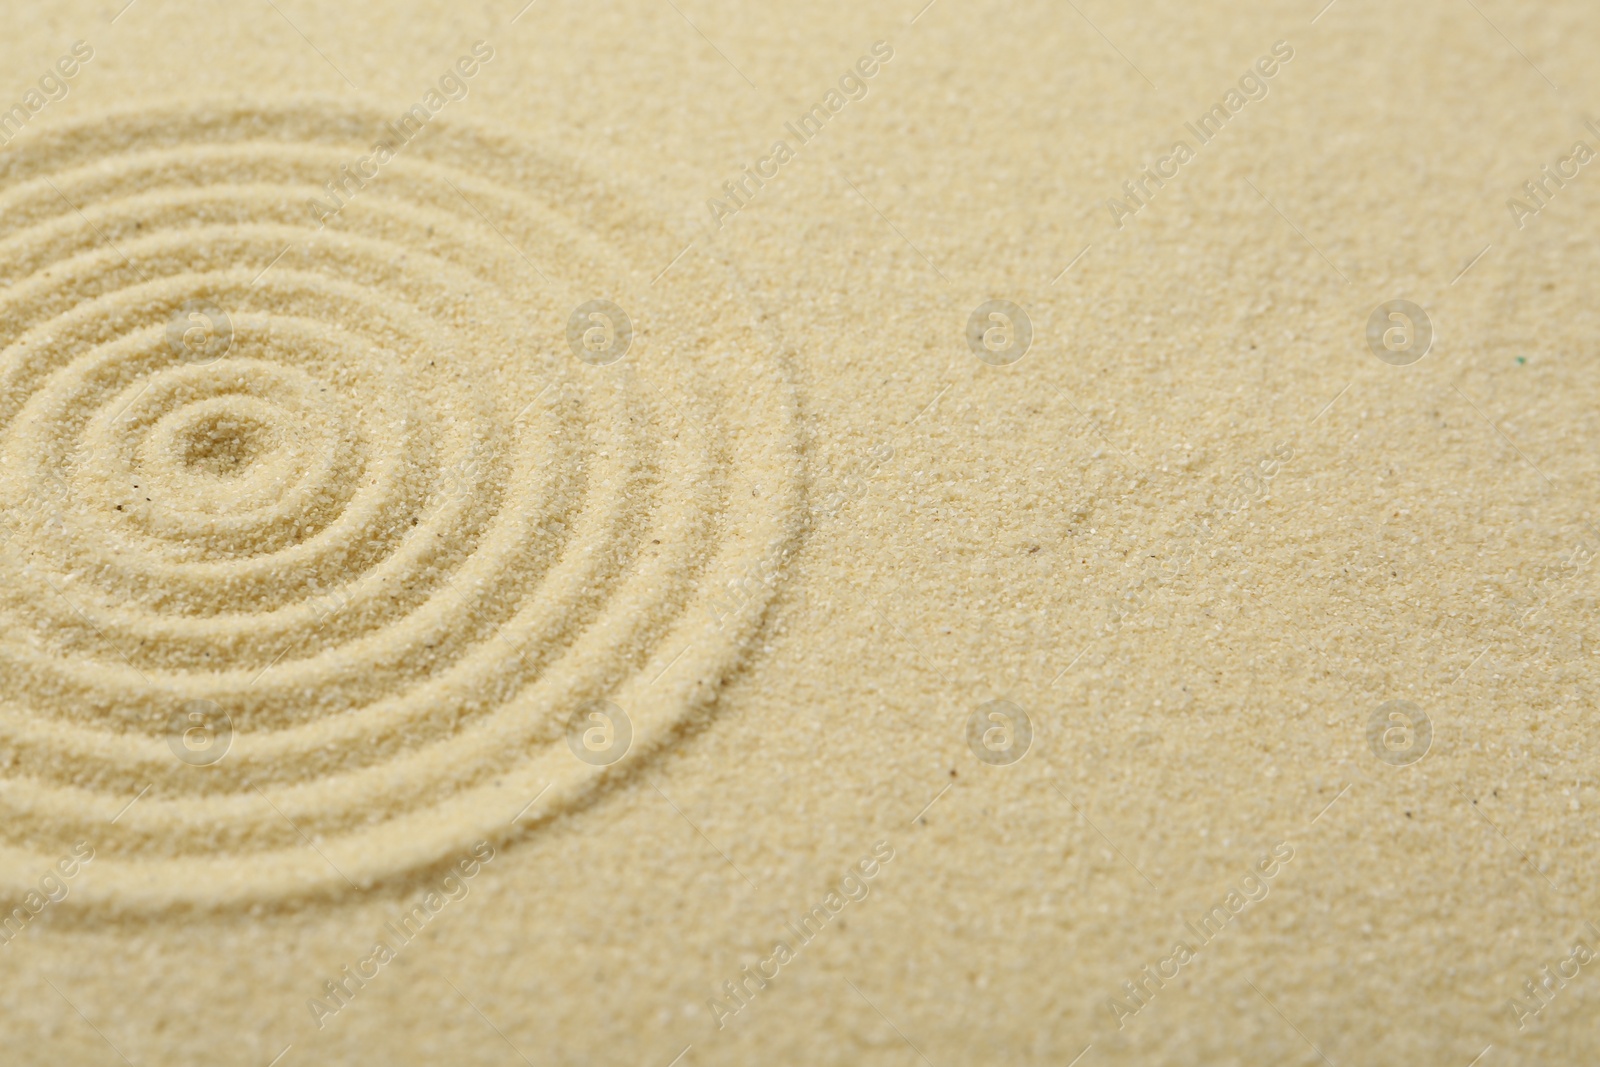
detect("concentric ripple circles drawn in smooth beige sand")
(0, 106), (800, 909)
